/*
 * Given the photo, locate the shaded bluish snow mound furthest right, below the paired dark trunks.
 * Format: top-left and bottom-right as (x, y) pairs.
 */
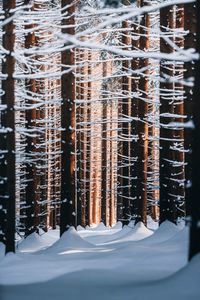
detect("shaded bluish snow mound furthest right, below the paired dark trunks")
(141, 221), (180, 243)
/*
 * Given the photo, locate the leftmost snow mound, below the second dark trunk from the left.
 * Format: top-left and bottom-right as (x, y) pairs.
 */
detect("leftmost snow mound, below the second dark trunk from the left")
(18, 232), (46, 252)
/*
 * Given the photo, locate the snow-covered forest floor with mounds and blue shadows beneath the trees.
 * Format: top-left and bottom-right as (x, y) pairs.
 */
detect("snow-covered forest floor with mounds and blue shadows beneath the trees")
(0, 220), (200, 300)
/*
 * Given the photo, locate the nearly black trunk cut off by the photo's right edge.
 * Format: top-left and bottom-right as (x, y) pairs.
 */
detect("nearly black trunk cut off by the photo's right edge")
(189, 1), (200, 259)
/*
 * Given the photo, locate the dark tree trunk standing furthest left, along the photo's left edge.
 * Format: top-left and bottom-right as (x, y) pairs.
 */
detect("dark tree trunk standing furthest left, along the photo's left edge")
(0, 0), (16, 252)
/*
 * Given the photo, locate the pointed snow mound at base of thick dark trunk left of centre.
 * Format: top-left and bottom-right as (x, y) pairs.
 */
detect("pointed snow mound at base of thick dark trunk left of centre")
(45, 227), (95, 253)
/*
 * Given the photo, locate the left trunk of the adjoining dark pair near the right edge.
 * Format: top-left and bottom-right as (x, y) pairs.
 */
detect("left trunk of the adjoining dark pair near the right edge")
(160, 7), (176, 223)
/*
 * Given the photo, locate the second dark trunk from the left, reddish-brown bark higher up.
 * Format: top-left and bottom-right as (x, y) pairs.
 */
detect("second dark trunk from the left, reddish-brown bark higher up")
(25, 8), (40, 236)
